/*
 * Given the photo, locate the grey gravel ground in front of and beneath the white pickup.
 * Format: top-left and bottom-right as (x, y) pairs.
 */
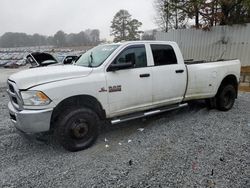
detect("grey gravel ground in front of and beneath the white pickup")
(0, 89), (250, 188)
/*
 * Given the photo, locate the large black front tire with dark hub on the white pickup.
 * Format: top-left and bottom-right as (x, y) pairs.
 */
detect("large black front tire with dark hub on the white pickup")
(55, 108), (100, 152)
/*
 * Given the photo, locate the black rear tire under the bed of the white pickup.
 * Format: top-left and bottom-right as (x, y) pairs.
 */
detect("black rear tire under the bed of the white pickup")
(216, 85), (236, 111)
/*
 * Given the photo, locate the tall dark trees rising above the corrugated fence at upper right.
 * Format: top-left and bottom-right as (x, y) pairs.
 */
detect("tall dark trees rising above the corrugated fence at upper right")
(154, 0), (250, 32)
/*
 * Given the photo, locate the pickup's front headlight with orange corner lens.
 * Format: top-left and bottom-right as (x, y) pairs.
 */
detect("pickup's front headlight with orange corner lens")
(21, 91), (51, 106)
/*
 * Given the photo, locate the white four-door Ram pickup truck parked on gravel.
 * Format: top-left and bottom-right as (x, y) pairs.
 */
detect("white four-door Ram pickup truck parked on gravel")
(7, 41), (241, 151)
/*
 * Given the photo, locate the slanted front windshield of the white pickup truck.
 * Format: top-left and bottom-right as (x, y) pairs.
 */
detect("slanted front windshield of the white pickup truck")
(75, 44), (119, 67)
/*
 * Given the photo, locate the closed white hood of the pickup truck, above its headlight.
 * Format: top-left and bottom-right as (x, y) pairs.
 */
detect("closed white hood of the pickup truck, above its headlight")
(9, 65), (93, 89)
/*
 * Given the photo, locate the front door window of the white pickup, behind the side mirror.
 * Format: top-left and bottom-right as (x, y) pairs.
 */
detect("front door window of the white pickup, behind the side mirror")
(114, 45), (147, 68)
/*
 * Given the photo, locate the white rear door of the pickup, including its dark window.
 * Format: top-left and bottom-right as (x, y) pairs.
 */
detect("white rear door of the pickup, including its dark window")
(150, 44), (187, 105)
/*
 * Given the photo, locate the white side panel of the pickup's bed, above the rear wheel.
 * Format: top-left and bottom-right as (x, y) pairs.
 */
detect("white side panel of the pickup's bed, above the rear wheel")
(184, 60), (241, 101)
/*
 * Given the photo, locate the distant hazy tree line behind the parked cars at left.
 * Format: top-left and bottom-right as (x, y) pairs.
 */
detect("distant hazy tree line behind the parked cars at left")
(0, 29), (100, 48)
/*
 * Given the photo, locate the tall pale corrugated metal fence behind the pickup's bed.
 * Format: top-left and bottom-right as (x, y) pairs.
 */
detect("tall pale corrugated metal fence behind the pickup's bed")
(156, 24), (250, 66)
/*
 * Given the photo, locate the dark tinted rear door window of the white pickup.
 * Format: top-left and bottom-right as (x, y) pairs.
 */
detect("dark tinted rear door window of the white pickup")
(151, 44), (177, 66)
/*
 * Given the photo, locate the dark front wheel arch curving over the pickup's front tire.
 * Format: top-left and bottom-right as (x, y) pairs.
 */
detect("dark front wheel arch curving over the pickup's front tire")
(50, 95), (106, 129)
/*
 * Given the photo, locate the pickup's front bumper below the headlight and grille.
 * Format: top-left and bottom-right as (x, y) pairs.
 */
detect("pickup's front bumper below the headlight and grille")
(8, 102), (53, 133)
